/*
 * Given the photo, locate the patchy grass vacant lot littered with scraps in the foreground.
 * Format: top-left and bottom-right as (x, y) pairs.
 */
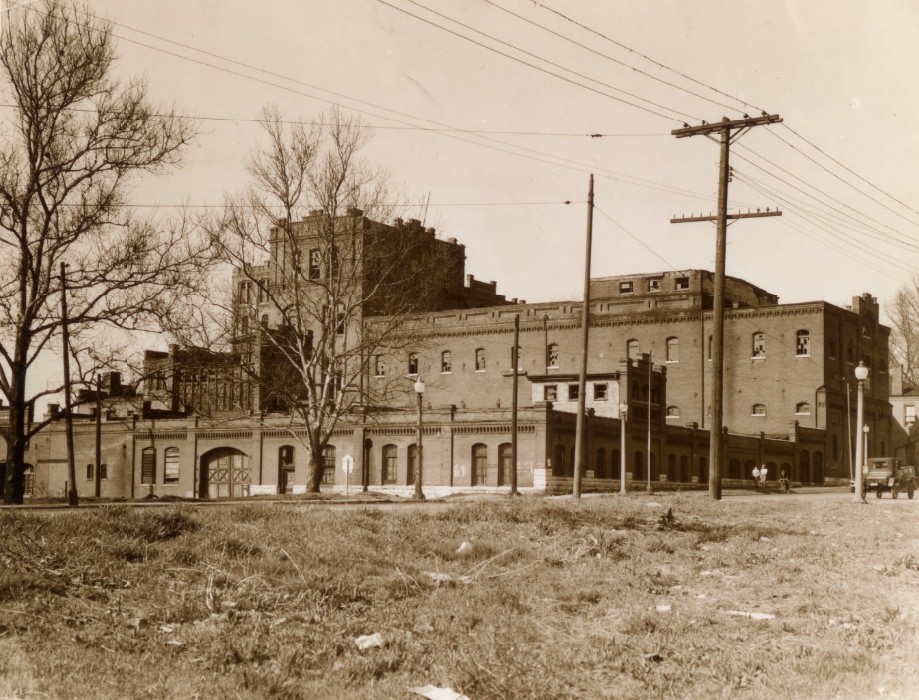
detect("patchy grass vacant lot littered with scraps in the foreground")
(0, 493), (919, 700)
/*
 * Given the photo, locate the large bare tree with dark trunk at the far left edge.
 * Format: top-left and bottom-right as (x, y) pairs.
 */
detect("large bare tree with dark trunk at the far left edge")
(0, 0), (204, 503)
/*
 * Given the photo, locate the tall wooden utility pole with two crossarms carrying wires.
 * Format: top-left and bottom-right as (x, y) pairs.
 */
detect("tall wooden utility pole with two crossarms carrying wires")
(668, 112), (782, 500)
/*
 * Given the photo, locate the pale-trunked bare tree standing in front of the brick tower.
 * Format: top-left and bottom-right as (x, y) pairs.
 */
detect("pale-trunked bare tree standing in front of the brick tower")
(211, 108), (463, 491)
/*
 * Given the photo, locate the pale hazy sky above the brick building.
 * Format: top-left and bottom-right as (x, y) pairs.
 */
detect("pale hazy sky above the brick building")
(54, 0), (919, 314)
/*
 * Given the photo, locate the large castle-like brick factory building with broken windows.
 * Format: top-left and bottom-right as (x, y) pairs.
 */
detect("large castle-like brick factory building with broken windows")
(14, 210), (892, 497)
